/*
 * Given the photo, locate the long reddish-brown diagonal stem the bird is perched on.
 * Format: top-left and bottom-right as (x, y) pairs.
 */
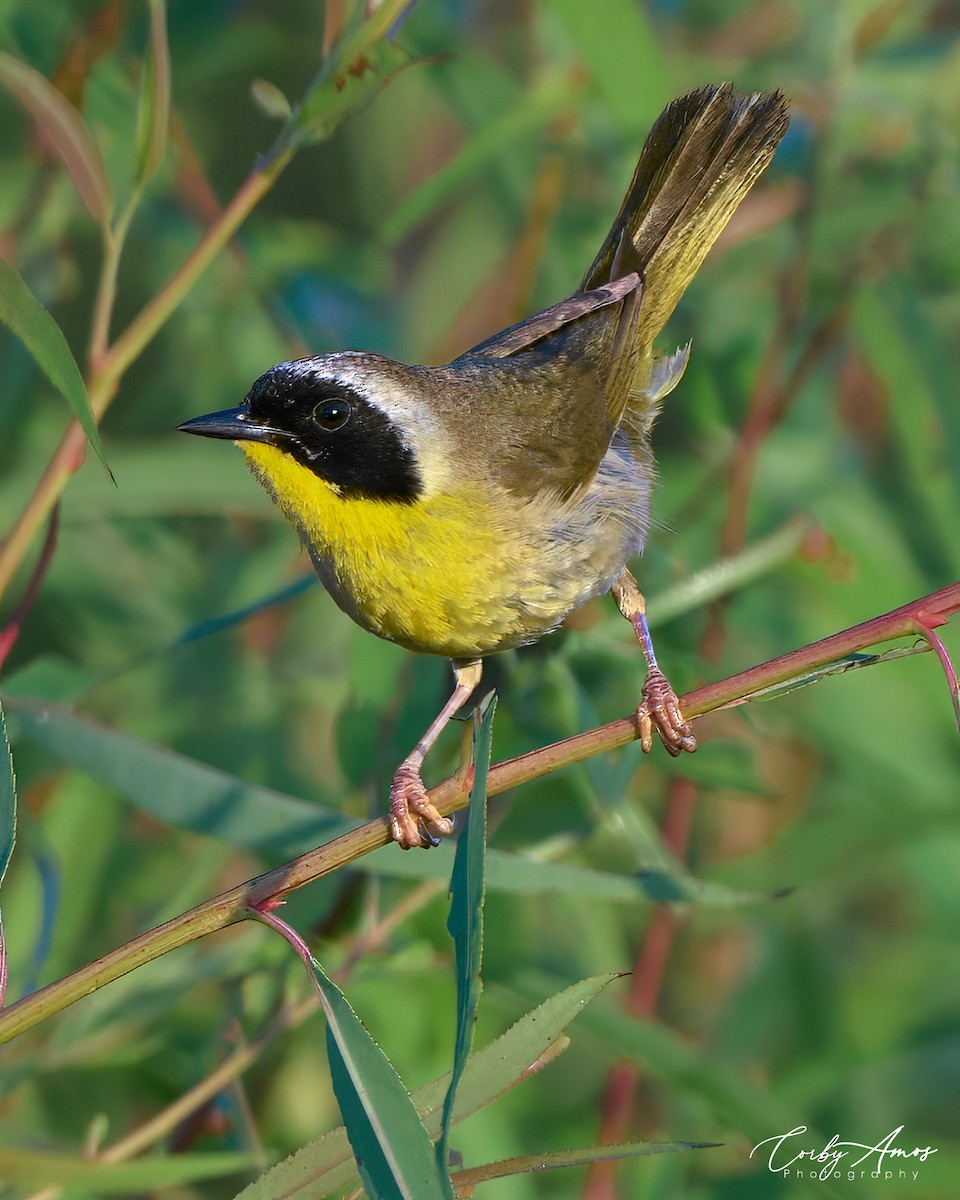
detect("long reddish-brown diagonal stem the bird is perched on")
(0, 583), (960, 1044)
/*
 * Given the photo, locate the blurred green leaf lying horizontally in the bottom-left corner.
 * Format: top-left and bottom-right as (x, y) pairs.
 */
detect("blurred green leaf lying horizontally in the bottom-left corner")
(0, 1146), (254, 1195)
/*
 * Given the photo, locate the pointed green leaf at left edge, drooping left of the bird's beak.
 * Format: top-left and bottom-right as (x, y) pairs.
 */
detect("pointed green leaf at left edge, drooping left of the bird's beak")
(0, 260), (106, 466)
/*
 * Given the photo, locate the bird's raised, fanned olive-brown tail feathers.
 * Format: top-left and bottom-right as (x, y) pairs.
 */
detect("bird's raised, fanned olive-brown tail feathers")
(581, 83), (790, 359)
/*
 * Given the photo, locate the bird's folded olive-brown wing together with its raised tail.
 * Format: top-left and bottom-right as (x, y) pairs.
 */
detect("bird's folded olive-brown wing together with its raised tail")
(446, 84), (788, 496)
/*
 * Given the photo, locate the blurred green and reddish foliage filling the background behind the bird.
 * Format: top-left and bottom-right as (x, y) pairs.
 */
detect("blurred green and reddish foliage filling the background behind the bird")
(0, 0), (960, 1200)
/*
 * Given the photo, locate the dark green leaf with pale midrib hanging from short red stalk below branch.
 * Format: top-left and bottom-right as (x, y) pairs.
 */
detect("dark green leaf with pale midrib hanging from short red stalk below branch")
(312, 960), (452, 1200)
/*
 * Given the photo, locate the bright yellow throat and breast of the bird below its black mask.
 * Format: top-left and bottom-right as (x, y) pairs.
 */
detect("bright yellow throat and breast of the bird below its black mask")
(241, 442), (535, 658)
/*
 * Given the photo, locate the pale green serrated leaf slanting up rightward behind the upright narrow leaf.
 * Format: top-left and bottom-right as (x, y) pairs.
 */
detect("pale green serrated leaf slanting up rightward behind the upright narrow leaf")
(238, 974), (618, 1200)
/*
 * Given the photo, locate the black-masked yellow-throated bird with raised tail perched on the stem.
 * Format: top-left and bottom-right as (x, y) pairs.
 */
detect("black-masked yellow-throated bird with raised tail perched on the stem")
(180, 84), (790, 848)
